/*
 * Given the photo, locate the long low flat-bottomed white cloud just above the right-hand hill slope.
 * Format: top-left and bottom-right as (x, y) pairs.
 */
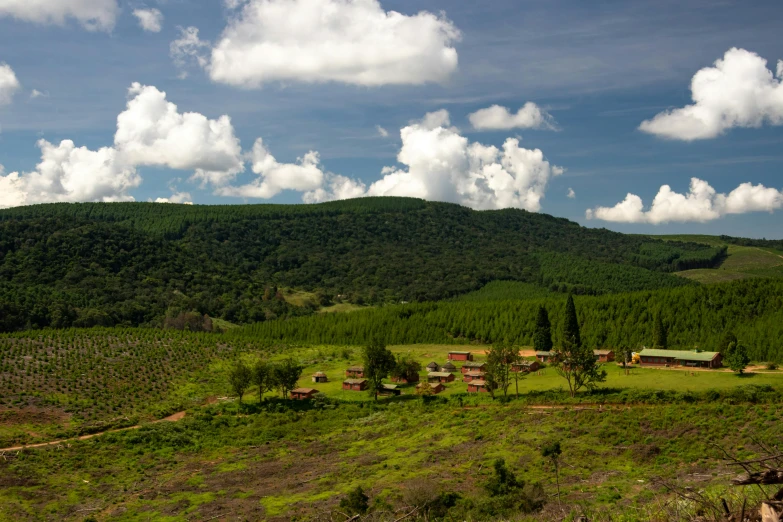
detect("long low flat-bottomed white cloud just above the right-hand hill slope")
(586, 178), (783, 225)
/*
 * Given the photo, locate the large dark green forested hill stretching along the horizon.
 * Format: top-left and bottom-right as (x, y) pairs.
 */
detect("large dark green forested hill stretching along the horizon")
(0, 198), (725, 330)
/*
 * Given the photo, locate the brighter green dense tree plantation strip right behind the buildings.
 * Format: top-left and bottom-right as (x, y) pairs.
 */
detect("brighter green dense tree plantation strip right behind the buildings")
(233, 279), (783, 362)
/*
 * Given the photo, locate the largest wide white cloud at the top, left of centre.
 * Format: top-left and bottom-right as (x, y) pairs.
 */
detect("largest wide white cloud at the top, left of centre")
(202, 0), (460, 88)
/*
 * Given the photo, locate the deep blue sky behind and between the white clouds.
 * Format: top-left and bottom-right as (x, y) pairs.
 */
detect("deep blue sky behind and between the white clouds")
(0, 0), (783, 238)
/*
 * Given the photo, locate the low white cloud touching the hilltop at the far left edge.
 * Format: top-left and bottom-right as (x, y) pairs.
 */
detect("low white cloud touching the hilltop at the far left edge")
(0, 140), (141, 208)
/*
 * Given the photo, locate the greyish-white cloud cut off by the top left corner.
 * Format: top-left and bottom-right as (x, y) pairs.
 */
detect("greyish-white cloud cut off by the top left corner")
(0, 0), (120, 31)
